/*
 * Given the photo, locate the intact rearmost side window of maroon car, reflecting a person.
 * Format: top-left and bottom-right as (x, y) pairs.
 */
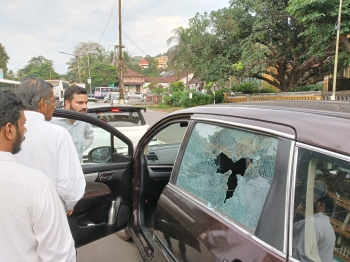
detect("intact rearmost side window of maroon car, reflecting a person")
(291, 148), (350, 261)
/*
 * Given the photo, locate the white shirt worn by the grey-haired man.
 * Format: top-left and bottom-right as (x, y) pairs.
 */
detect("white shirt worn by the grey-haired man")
(15, 111), (85, 211)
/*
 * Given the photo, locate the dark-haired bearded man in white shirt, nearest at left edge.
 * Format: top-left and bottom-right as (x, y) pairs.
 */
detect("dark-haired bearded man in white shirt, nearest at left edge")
(0, 91), (76, 262)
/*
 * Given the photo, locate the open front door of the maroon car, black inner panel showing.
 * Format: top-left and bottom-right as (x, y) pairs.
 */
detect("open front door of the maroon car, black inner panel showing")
(53, 109), (133, 248)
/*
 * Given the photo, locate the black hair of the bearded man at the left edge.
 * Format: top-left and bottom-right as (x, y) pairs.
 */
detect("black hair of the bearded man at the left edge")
(0, 91), (23, 128)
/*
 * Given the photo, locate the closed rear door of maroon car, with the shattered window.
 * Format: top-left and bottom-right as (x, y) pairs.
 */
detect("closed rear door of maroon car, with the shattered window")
(154, 121), (292, 262)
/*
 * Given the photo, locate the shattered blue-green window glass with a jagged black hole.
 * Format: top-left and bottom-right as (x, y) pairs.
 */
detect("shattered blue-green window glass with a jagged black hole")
(176, 123), (278, 232)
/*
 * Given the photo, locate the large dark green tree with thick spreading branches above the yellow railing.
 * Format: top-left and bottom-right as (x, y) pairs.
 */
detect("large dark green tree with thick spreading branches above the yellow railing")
(176, 0), (340, 91)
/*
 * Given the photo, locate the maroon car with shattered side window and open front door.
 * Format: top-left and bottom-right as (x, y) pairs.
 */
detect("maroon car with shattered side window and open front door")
(50, 101), (350, 262)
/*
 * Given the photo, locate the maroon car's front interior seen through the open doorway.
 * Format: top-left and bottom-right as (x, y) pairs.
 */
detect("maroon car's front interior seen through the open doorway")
(135, 120), (188, 247)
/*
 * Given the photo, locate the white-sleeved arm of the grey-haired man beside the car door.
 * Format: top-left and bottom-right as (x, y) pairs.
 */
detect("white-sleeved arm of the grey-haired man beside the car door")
(56, 128), (86, 211)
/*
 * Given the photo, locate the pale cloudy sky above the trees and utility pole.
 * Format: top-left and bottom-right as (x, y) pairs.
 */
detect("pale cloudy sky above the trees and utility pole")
(0, 0), (229, 74)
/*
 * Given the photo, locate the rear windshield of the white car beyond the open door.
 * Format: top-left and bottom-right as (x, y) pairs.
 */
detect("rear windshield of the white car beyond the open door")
(88, 109), (146, 127)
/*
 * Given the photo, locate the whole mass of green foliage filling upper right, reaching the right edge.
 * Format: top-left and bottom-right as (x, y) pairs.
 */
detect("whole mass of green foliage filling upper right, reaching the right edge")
(165, 0), (350, 91)
